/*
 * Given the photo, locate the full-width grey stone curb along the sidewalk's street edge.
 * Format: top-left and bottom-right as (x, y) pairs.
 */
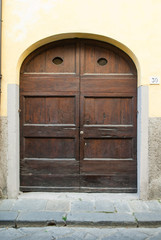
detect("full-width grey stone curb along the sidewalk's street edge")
(0, 211), (161, 228)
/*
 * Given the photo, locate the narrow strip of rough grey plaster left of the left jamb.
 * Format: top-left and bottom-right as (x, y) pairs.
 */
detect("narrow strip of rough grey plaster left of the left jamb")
(0, 117), (7, 198)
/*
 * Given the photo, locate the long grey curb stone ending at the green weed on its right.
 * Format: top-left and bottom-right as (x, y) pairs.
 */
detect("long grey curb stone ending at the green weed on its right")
(16, 211), (65, 226)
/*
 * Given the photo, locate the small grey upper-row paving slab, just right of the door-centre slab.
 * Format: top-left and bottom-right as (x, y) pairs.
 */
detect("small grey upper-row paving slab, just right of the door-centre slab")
(95, 200), (115, 213)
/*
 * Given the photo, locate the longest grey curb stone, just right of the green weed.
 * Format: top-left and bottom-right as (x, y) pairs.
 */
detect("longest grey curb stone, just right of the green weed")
(67, 212), (136, 226)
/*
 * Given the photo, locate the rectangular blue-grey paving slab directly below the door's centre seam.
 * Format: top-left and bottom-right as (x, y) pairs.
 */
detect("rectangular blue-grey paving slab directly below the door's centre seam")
(71, 201), (95, 212)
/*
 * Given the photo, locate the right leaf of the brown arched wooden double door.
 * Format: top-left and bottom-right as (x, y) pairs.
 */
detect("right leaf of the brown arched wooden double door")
(80, 41), (137, 192)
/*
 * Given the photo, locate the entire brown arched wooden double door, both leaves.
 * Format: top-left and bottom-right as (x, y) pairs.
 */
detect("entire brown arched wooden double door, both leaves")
(20, 39), (137, 192)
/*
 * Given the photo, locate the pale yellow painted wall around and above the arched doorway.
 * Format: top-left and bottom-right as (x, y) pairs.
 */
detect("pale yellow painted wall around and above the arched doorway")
(1, 0), (161, 117)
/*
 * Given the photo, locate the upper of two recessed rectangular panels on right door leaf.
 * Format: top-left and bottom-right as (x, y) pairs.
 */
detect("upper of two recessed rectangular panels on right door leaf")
(84, 97), (133, 125)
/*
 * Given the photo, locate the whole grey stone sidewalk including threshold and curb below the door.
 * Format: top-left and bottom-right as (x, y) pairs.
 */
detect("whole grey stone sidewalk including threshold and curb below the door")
(0, 193), (161, 227)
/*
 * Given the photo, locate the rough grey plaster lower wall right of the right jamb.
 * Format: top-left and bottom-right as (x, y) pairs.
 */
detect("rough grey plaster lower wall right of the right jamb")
(149, 118), (161, 199)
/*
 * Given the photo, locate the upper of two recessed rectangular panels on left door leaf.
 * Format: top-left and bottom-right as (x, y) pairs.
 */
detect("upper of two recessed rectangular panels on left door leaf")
(25, 96), (76, 125)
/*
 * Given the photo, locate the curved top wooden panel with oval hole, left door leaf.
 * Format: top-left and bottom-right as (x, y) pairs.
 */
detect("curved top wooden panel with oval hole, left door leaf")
(21, 41), (77, 74)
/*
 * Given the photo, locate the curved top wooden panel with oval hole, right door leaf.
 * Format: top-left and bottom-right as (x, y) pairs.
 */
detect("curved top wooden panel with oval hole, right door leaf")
(81, 41), (136, 74)
